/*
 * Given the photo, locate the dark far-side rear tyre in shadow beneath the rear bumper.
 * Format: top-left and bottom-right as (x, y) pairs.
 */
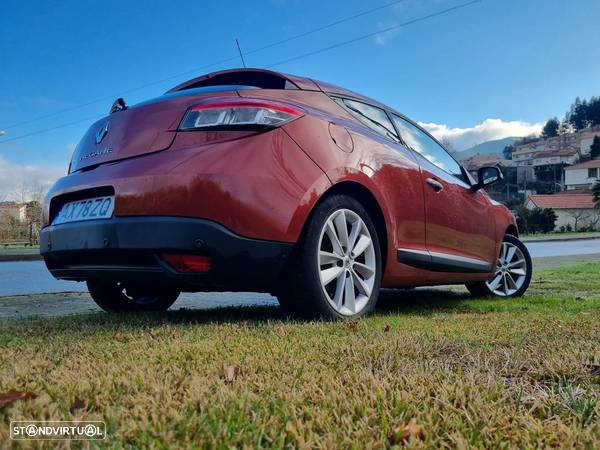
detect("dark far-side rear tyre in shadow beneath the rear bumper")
(87, 280), (179, 312)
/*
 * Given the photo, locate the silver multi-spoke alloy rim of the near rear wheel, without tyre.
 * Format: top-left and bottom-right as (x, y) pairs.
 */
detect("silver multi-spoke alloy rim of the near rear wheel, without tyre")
(318, 209), (377, 316)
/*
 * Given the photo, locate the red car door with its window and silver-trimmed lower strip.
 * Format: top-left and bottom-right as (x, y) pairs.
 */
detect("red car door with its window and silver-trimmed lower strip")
(391, 114), (496, 273)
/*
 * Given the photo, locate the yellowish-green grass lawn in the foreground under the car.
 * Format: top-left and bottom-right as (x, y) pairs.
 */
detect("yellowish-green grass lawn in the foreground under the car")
(0, 263), (600, 449)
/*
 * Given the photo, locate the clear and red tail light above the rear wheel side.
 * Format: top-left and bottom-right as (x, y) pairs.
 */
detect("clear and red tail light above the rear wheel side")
(179, 99), (303, 130)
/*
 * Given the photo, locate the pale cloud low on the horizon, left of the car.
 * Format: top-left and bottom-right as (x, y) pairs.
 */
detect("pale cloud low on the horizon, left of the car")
(0, 155), (66, 201)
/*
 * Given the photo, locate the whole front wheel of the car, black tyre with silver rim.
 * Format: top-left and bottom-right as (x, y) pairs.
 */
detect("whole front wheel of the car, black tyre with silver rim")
(466, 234), (533, 298)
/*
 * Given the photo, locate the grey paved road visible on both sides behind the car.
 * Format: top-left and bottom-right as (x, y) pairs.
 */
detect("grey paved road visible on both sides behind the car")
(0, 239), (600, 297)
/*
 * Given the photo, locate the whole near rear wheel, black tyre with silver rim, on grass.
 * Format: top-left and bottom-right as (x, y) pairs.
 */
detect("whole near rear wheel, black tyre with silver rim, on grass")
(277, 195), (382, 319)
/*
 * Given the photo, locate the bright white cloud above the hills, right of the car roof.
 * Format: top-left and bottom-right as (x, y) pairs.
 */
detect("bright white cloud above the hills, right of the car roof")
(419, 119), (544, 151)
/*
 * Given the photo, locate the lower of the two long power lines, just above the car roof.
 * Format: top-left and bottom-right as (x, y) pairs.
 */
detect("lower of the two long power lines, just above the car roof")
(0, 0), (483, 144)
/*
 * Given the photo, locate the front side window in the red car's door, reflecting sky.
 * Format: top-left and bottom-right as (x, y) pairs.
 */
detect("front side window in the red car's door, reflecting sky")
(392, 114), (470, 184)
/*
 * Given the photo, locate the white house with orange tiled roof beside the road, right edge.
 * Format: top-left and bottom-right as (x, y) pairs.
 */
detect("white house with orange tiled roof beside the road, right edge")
(525, 191), (600, 231)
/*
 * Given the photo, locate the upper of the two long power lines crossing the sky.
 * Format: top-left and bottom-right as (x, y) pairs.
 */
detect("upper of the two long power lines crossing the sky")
(4, 0), (406, 130)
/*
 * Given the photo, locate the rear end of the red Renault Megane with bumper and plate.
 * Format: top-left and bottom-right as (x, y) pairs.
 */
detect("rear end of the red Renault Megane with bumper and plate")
(41, 67), (336, 291)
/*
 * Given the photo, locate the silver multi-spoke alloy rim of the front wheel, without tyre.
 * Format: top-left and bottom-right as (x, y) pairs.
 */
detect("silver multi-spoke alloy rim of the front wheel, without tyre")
(486, 241), (528, 297)
